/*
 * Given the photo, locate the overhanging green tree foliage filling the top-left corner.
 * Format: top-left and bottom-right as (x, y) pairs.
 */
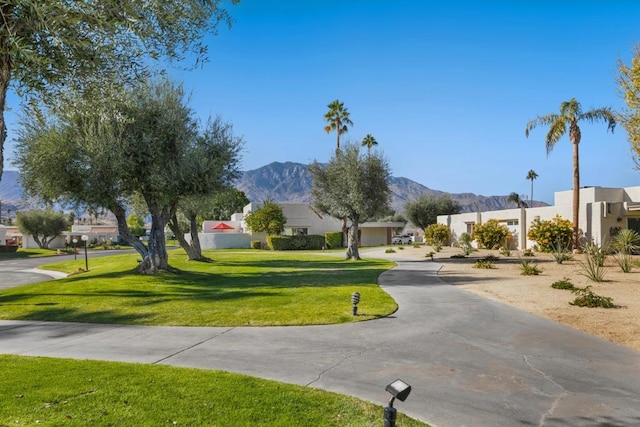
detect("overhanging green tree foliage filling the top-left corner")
(0, 0), (239, 177)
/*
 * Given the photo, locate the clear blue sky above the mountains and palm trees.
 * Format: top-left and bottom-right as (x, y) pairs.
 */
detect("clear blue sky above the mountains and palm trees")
(5, 0), (640, 203)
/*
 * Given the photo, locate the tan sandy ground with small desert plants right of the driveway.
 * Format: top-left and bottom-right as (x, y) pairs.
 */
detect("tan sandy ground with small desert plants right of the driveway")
(396, 247), (640, 351)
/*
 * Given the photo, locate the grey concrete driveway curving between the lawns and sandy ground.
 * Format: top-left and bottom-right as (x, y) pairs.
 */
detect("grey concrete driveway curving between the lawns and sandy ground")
(0, 254), (640, 427)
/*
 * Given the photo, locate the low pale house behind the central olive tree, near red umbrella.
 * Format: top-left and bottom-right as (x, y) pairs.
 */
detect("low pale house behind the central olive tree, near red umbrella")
(194, 203), (405, 249)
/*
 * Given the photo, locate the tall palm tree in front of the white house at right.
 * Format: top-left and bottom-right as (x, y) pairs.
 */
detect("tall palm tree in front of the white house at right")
(525, 98), (616, 249)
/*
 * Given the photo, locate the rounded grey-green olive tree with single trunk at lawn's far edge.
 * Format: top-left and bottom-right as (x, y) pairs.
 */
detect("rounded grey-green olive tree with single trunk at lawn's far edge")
(309, 142), (391, 260)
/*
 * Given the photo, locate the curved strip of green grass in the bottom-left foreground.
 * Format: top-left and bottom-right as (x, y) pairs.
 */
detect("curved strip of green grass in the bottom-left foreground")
(0, 356), (426, 427)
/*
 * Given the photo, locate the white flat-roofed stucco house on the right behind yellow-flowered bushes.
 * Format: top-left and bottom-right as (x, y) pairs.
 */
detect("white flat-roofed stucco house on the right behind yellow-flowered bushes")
(438, 187), (640, 249)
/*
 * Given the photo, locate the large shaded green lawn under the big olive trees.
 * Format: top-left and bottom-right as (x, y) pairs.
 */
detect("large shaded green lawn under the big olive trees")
(0, 250), (397, 326)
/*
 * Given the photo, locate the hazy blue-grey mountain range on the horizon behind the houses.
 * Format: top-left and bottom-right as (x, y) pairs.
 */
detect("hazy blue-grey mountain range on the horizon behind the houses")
(0, 162), (547, 214)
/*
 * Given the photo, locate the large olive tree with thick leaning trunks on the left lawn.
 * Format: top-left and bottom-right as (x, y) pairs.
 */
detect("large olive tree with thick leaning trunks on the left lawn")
(16, 80), (242, 273)
